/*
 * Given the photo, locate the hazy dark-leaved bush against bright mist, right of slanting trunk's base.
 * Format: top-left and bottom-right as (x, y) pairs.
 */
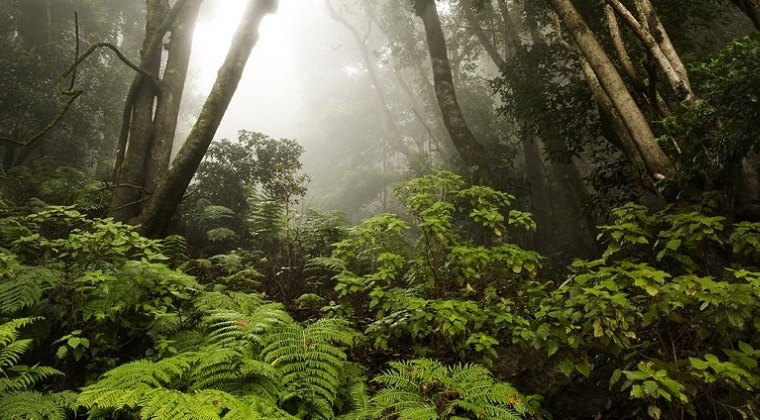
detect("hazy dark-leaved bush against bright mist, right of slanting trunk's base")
(180, 130), (308, 255)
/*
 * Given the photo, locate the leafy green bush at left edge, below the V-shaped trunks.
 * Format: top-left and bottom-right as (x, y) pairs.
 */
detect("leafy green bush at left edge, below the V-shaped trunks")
(0, 206), (199, 378)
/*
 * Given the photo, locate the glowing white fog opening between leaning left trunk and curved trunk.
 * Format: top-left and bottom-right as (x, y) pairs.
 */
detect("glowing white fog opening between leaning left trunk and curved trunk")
(187, 0), (448, 217)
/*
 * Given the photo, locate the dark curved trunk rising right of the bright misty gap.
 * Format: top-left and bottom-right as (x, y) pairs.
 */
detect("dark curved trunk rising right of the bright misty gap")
(414, 0), (492, 184)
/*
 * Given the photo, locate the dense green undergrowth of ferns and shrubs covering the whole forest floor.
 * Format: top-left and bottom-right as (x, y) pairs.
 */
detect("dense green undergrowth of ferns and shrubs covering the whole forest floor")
(0, 168), (760, 419)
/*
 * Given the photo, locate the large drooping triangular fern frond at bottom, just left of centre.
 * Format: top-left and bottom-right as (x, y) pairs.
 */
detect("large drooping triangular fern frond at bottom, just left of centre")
(262, 318), (356, 418)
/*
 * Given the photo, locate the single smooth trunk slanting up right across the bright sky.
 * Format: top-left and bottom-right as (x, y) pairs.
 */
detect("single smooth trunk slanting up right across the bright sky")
(136, 0), (278, 236)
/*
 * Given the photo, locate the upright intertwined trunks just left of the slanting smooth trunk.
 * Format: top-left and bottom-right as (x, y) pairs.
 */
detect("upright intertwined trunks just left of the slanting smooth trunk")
(111, 0), (201, 221)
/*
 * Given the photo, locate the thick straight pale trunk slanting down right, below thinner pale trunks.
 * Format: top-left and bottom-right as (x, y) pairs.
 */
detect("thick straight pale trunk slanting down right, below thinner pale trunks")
(547, 0), (672, 180)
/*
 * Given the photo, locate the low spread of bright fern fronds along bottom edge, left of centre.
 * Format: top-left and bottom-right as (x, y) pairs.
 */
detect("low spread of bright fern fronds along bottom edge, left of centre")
(77, 347), (285, 419)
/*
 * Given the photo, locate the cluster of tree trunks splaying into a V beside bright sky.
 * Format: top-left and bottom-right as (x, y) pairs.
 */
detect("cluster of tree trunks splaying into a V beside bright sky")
(111, 0), (278, 236)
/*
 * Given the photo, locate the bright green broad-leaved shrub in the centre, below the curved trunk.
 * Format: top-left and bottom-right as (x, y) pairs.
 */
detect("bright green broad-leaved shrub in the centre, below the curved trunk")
(313, 172), (541, 363)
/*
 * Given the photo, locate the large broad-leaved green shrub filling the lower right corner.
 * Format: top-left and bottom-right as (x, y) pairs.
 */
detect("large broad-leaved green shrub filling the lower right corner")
(507, 205), (760, 418)
